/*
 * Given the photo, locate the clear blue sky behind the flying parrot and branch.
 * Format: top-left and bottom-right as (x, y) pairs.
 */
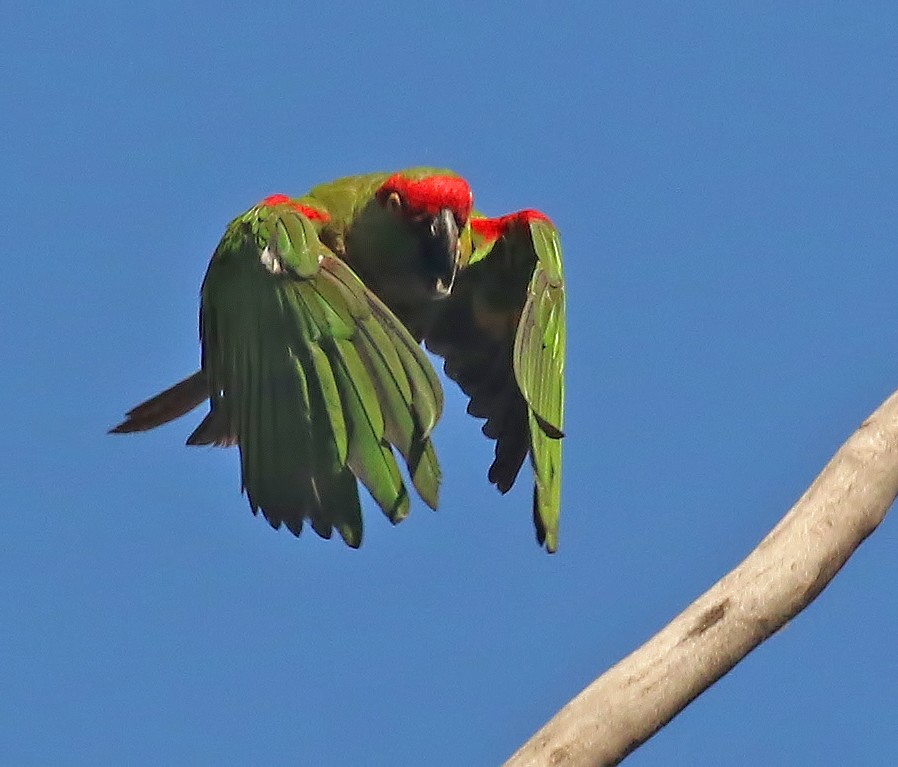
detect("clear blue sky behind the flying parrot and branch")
(0, 2), (898, 767)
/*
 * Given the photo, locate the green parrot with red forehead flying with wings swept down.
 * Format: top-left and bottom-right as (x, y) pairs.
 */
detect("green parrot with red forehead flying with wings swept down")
(111, 168), (565, 552)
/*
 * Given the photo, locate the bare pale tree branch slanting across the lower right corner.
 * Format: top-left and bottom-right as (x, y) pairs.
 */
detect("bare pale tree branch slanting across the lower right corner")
(505, 392), (898, 767)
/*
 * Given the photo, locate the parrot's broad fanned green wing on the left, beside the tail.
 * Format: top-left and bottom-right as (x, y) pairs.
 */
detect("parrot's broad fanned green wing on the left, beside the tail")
(201, 195), (443, 546)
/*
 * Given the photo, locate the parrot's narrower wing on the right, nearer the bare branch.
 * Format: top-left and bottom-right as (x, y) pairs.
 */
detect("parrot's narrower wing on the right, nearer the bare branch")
(426, 210), (565, 551)
